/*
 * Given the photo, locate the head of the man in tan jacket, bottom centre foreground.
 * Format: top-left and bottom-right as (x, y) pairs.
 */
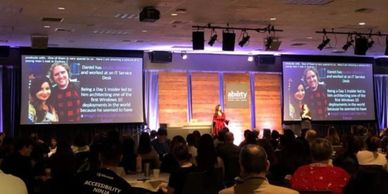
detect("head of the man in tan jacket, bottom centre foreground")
(240, 144), (269, 175)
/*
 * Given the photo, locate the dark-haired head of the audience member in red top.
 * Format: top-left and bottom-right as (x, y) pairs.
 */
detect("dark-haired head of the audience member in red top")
(310, 138), (333, 162)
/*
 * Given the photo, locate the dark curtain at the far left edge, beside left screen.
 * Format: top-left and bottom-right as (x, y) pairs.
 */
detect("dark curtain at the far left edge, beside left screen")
(2, 66), (20, 137)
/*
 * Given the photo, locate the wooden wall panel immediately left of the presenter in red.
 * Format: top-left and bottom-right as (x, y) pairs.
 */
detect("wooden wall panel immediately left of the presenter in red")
(191, 73), (220, 124)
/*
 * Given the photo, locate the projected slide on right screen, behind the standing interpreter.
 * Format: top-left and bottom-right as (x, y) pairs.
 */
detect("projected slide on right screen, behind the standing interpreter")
(283, 61), (375, 121)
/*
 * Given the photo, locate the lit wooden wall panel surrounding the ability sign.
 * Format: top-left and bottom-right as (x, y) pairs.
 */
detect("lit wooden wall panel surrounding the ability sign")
(224, 73), (251, 142)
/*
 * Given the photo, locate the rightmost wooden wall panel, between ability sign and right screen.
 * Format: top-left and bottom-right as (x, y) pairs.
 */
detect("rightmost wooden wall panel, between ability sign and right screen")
(255, 74), (282, 130)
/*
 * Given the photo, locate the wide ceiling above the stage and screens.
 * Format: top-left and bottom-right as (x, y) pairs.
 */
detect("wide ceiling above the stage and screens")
(0, 0), (388, 56)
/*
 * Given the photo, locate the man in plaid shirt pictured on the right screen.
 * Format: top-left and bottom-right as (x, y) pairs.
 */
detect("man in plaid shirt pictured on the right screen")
(303, 67), (328, 120)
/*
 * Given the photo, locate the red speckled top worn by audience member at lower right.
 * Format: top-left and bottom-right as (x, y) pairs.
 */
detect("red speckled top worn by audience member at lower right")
(290, 165), (350, 194)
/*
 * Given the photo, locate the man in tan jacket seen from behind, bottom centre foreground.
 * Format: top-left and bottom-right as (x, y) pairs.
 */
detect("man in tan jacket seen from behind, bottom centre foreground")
(220, 144), (298, 194)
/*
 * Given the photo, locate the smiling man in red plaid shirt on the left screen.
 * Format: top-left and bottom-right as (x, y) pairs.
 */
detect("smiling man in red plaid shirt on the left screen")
(48, 62), (81, 123)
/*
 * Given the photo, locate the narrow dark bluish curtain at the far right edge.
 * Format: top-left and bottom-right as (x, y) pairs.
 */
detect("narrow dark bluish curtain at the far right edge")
(374, 75), (388, 129)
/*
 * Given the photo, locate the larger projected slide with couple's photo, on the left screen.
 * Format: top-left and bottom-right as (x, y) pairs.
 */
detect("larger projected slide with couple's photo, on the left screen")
(20, 55), (144, 124)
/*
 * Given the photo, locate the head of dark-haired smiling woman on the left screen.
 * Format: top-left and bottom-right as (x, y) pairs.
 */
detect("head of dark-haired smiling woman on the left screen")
(30, 77), (51, 102)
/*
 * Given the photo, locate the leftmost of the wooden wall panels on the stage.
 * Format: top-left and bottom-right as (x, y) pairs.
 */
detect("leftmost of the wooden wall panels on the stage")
(159, 72), (187, 127)
